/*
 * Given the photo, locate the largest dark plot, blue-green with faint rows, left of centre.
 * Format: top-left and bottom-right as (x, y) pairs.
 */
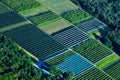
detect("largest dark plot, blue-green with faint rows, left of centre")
(4, 24), (64, 60)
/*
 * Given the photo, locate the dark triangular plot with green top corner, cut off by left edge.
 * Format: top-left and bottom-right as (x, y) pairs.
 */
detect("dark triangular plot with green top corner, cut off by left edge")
(0, 3), (26, 28)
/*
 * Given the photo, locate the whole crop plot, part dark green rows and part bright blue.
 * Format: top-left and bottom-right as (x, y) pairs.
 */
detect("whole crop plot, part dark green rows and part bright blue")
(47, 51), (93, 75)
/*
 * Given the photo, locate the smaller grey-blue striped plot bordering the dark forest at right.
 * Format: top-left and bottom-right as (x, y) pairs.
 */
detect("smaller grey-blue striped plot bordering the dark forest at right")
(76, 18), (106, 32)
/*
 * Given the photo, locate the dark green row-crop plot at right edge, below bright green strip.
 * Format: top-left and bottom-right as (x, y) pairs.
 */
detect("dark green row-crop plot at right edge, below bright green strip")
(105, 61), (120, 80)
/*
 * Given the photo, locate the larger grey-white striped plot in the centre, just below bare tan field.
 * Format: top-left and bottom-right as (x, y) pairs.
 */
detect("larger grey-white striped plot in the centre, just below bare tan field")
(52, 26), (90, 47)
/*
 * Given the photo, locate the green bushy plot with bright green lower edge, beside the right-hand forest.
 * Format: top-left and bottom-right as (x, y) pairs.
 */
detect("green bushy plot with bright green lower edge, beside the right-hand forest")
(62, 9), (92, 25)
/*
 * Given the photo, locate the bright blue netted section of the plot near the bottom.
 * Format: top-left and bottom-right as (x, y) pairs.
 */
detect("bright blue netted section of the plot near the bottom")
(56, 54), (92, 75)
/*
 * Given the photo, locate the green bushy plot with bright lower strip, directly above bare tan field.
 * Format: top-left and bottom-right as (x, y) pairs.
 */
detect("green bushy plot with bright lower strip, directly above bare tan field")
(29, 11), (59, 25)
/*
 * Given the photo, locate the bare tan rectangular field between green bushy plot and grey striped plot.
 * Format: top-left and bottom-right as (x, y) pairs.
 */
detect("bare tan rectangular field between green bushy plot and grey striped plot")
(38, 18), (71, 34)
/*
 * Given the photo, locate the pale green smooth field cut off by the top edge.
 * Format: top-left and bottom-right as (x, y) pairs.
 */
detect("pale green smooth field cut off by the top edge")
(37, 0), (78, 14)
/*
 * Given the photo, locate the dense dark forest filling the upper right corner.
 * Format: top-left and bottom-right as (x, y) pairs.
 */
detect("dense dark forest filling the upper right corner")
(71, 0), (120, 54)
